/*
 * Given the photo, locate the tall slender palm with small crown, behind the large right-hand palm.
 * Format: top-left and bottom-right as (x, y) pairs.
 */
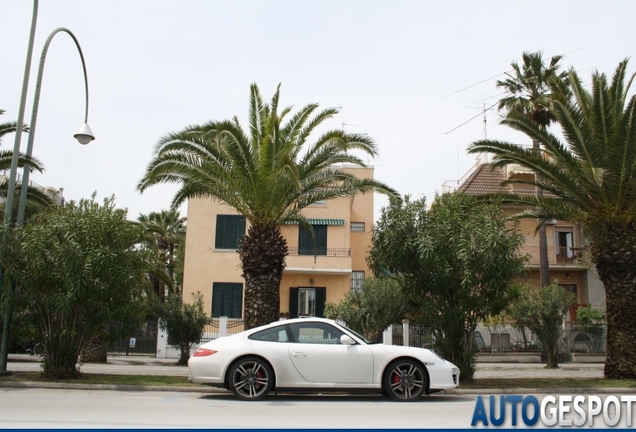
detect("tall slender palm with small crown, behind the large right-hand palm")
(497, 52), (567, 286)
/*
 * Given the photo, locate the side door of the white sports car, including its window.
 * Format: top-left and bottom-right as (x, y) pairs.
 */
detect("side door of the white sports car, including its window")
(289, 321), (373, 384)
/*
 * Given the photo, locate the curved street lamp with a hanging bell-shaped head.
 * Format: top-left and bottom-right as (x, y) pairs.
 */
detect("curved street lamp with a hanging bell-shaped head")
(16, 27), (95, 227)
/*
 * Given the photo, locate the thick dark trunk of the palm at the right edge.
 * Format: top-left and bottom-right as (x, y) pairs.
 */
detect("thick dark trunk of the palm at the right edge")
(592, 227), (636, 379)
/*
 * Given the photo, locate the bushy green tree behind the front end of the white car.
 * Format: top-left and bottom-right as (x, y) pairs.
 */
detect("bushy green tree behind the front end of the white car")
(368, 193), (525, 380)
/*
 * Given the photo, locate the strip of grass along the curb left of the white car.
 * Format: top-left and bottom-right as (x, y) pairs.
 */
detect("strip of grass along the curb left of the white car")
(0, 372), (200, 387)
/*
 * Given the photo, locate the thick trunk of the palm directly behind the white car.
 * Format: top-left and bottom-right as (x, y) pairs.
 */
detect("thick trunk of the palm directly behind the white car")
(238, 225), (287, 330)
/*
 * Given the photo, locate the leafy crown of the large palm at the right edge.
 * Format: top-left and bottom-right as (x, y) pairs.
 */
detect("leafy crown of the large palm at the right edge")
(469, 60), (636, 230)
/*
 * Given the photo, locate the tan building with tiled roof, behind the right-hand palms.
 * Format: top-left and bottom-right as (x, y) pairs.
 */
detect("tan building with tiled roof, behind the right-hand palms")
(450, 160), (605, 321)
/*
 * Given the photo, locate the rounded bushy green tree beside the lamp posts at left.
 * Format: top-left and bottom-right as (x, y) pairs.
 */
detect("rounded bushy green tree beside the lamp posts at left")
(7, 195), (158, 378)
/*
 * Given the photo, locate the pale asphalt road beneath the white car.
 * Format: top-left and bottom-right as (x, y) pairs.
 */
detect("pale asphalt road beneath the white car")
(0, 388), (635, 429)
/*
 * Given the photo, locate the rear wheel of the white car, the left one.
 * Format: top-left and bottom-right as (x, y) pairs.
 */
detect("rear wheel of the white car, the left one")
(229, 357), (274, 401)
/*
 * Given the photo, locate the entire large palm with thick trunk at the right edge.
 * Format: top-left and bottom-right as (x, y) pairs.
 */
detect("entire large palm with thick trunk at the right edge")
(469, 60), (636, 379)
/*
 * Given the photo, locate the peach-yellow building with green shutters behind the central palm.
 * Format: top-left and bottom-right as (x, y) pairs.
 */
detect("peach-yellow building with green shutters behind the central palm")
(183, 166), (373, 318)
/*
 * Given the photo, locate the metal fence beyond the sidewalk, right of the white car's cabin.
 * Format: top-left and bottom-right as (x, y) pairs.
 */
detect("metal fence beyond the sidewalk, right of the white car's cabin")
(392, 323), (607, 362)
